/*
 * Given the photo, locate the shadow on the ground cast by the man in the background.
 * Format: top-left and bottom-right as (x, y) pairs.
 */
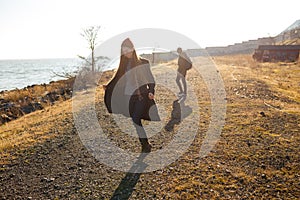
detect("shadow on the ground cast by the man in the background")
(164, 99), (193, 132)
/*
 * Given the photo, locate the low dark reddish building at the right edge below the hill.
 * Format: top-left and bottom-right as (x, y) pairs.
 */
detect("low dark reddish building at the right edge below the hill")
(252, 45), (300, 62)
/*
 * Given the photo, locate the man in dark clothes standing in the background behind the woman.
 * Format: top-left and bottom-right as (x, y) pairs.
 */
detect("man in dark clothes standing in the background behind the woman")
(176, 47), (192, 98)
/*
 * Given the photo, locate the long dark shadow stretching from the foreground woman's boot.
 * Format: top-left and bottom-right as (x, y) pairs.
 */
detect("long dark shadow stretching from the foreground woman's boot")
(110, 153), (147, 200)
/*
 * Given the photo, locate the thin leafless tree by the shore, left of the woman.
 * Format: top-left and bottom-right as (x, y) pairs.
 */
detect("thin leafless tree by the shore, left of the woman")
(78, 26), (100, 72)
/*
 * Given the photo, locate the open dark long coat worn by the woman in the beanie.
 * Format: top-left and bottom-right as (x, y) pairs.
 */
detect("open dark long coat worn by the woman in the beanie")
(104, 58), (160, 121)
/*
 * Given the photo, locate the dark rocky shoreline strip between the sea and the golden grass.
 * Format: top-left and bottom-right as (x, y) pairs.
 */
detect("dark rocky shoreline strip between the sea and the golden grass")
(0, 78), (75, 125)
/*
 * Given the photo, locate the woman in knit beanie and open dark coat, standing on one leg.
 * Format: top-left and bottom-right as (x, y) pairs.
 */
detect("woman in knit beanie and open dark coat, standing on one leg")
(104, 38), (160, 153)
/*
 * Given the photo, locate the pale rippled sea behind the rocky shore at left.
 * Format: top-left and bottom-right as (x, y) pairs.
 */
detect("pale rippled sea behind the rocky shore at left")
(0, 58), (115, 91)
